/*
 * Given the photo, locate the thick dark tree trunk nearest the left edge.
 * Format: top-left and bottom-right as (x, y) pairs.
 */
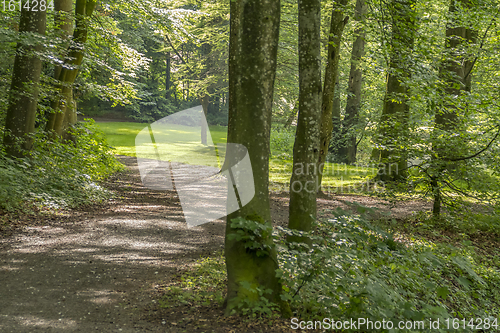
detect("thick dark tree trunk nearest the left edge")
(3, 8), (47, 157)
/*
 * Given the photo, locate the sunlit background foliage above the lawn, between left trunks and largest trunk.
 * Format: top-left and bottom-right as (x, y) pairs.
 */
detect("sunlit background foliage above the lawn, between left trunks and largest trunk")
(74, 0), (229, 125)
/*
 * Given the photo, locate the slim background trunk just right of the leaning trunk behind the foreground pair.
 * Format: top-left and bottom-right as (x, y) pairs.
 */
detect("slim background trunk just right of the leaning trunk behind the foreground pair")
(339, 0), (366, 164)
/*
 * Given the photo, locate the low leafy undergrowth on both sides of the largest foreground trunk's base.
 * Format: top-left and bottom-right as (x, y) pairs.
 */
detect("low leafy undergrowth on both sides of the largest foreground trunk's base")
(160, 212), (500, 332)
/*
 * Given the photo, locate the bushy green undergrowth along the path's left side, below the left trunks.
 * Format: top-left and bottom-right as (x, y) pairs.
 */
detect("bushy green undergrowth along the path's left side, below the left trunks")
(0, 121), (122, 211)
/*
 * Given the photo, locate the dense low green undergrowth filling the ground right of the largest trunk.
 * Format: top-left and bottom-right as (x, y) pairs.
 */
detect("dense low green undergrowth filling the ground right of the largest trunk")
(279, 212), (500, 331)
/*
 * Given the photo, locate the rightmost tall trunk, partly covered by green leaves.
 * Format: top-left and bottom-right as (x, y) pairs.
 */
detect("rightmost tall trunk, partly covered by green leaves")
(430, 0), (477, 217)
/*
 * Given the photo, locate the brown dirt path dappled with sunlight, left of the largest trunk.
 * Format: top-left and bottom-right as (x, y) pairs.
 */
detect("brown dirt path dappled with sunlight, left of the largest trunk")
(0, 159), (224, 333)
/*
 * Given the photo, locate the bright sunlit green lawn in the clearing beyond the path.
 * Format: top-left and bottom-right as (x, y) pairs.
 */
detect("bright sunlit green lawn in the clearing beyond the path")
(97, 122), (376, 192)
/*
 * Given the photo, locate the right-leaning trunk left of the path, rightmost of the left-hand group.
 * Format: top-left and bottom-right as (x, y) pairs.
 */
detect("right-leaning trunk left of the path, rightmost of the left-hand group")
(46, 0), (96, 137)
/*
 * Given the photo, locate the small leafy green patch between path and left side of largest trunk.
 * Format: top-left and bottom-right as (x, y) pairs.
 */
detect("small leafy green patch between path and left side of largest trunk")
(159, 253), (226, 308)
